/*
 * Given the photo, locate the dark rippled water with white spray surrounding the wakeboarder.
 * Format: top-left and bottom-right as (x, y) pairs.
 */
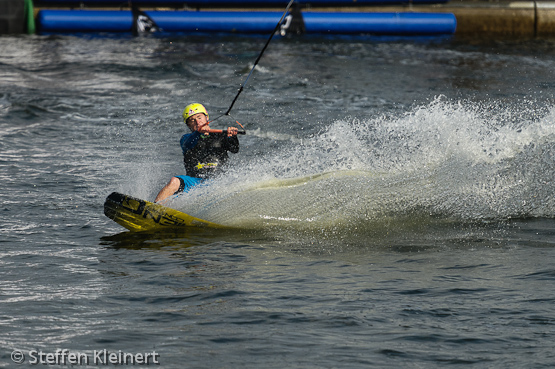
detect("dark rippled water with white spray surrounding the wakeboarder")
(0, 35), (555, 368)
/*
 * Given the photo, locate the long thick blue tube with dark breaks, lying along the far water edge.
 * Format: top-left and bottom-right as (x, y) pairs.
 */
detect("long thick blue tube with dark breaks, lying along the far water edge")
(37, 10), (457, 35)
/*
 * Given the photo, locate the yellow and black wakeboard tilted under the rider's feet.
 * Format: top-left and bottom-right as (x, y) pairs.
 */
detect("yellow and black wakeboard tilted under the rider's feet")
(104, 192), (227, 231)
